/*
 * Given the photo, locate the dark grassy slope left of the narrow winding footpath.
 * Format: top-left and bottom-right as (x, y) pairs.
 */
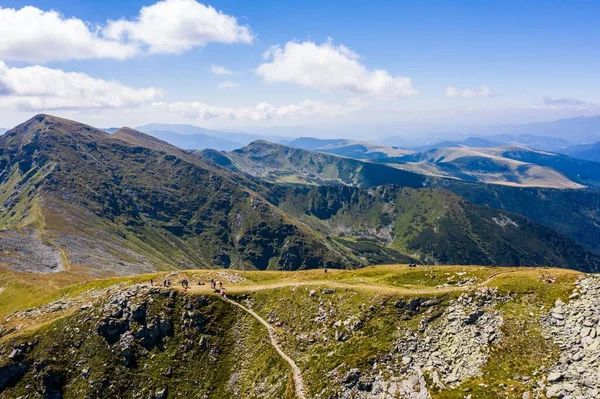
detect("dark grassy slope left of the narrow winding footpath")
(0, 290), (293, 399)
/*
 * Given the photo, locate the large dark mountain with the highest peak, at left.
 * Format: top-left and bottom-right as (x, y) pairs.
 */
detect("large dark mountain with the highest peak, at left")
(0, 115), (359, 273)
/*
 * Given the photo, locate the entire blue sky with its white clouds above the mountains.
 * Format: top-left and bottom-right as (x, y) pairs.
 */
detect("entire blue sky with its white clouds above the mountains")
(0, 0), (600, 138)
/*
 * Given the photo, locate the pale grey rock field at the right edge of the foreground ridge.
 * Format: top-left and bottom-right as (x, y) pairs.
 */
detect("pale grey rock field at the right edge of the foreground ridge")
(541, 276), (600, 398)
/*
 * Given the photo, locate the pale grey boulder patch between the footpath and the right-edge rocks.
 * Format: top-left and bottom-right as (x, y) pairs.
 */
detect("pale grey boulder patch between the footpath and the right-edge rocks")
(331, 288), (508, 399)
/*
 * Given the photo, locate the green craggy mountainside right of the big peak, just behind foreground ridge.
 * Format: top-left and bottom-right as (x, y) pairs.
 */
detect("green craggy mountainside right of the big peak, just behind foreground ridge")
(281, 186), (600, 271)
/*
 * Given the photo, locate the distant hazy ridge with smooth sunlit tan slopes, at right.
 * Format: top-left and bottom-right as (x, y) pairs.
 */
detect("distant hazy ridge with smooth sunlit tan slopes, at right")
(288, 137), (600, 189)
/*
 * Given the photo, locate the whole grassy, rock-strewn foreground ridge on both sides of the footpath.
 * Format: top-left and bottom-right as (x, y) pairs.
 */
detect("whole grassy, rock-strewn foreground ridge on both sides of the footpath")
(0, 268), (600, 399)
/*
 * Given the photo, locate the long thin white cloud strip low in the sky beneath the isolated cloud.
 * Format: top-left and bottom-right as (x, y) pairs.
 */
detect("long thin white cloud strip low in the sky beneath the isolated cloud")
(153, 99), (367, 121)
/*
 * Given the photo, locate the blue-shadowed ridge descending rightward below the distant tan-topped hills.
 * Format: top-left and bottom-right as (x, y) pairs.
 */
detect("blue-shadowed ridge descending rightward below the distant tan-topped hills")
(219, 142), (600, 251)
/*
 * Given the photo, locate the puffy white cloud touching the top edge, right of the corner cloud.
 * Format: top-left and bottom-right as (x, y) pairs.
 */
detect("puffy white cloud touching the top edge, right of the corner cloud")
(103, 0), (253, 54)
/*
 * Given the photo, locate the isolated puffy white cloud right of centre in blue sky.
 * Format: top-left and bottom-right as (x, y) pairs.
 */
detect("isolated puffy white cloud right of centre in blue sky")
(257, 41), (418, 97)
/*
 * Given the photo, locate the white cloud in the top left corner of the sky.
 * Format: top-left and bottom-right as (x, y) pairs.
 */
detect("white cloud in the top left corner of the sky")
(0, 7), (137, 62)
